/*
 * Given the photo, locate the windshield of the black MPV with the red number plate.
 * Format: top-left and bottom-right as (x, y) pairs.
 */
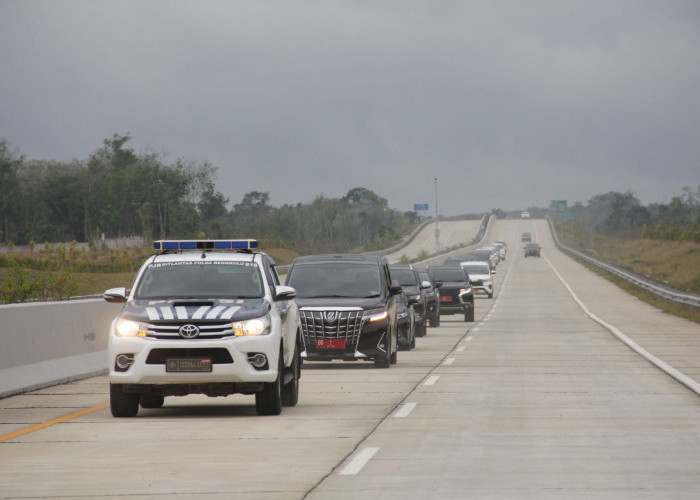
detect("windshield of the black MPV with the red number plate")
(287, 262), (381, 299)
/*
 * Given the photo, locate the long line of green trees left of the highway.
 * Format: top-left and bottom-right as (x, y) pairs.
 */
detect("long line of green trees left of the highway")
(0, 134), (419, 252)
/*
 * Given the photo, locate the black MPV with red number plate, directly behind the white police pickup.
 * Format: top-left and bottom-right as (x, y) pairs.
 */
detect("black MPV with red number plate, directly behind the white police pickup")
(286, 254), (402, 368)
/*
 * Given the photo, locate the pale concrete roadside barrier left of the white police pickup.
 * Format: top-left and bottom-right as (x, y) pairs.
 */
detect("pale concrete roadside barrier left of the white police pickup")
(0, 299), (122, 397)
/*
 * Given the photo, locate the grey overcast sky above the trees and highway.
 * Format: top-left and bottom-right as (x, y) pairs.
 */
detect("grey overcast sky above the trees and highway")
(0, 0), (700, 215)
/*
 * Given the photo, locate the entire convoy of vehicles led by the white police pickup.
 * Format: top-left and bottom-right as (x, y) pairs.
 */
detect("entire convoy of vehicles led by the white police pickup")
(104, 229), (516, 417)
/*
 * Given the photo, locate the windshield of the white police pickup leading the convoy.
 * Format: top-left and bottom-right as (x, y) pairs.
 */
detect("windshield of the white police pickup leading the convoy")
(134, 260), (263, 299)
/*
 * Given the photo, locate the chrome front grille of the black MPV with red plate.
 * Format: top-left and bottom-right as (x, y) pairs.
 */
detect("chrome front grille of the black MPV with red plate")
(299, 309), (363, 347)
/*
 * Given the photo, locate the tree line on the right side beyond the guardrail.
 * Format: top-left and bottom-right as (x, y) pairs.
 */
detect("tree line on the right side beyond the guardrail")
(570, 186), (700, 243)
